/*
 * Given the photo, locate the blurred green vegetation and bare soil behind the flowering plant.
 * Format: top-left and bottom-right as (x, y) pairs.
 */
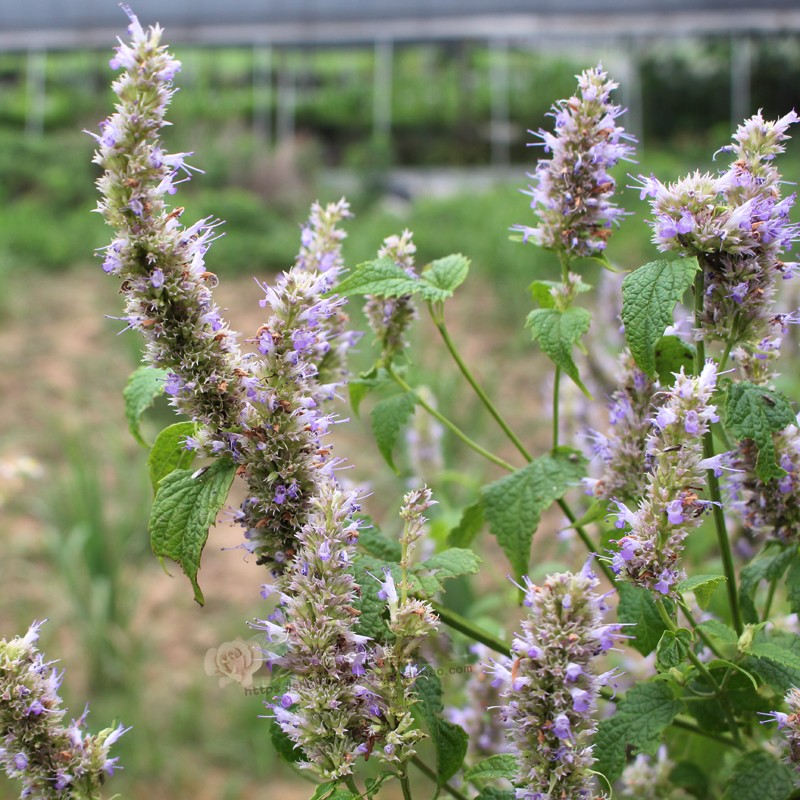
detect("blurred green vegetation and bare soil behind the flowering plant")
(0, 31), (800, 798)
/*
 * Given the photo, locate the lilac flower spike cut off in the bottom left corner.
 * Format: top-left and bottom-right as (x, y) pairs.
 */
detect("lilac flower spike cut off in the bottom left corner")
(0, 623), (127, 800)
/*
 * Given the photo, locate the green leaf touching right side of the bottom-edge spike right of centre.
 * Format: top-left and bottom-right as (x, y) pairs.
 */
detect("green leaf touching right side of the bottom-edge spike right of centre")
(594, 681), (681, 783)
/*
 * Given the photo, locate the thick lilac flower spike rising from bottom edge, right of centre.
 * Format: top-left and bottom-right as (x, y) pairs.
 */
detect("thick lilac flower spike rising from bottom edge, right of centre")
(494, 563), (622, 800)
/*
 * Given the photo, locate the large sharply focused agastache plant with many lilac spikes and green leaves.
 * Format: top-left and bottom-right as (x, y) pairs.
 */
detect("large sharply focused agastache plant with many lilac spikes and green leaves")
(84, 10), (800, 800)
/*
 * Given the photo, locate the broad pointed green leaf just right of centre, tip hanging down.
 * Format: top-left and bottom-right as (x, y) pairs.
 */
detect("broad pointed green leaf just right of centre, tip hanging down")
(481, 451), (585, 579)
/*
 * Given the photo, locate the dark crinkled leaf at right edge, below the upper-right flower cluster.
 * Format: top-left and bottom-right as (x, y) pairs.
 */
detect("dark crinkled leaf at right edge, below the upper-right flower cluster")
(724, 381), (795, 483)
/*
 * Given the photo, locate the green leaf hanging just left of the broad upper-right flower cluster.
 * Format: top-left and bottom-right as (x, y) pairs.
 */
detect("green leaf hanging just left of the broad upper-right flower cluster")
(622, 258), (700, 378)
